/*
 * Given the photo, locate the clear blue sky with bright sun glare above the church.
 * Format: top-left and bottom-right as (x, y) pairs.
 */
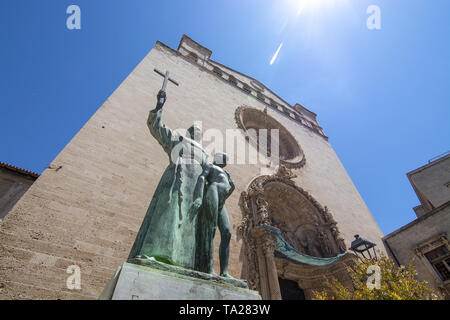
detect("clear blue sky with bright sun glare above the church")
(0, 0), (450, 234)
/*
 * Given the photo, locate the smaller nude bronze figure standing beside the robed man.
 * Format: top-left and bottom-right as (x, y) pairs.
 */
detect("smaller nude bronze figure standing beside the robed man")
(192, 153), (235, 278)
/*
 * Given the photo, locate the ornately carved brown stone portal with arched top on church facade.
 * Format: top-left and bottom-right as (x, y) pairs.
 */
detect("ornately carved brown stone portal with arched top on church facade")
(238, 166), (353, 299)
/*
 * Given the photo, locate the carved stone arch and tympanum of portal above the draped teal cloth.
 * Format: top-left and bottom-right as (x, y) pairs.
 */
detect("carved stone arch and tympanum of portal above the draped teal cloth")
(238, 165), (346, 296)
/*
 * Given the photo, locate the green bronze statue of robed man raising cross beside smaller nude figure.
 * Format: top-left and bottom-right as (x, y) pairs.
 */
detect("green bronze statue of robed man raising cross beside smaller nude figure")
(128, 75), (234, 278)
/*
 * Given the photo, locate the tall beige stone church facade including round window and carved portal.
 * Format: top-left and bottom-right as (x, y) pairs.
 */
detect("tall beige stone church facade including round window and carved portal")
(0, 36), (383, 299)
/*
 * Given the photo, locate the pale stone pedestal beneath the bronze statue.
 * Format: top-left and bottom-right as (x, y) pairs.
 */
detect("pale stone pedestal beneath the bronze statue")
(99, 263), (261, 300)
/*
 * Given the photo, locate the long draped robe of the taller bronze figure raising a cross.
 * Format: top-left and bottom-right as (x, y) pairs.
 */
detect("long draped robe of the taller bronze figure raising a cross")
(128, 110), (207, 269)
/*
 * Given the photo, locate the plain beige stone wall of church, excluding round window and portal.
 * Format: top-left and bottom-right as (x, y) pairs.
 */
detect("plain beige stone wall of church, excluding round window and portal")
(0, 38), (382, 299)
